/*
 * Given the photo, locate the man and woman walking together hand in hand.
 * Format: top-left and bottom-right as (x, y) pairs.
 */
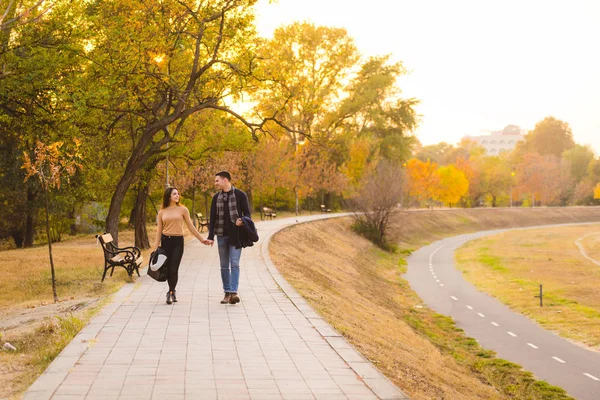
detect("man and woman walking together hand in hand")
(152, 171), (253, 304)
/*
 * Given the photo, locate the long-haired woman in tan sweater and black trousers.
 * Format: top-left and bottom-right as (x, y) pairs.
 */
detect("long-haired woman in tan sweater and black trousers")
(152, 187), (210, 304)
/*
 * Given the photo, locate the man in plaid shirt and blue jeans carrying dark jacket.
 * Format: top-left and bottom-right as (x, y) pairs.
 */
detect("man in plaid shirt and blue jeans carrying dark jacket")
(207, 171), (250, 304)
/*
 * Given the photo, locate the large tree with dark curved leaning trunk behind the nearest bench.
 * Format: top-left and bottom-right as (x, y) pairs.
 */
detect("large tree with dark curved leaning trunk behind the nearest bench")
(77, 0), (270, 241)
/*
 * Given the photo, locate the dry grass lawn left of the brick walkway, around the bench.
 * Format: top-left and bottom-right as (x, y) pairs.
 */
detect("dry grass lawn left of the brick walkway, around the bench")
(0, 227), (162, 398)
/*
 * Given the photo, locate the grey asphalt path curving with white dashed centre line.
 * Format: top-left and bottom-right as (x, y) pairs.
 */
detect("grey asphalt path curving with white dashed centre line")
(405, 222), (600, 400)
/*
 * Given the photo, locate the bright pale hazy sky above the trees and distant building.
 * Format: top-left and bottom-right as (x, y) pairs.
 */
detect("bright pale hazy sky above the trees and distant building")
(257, 0), (600, 155)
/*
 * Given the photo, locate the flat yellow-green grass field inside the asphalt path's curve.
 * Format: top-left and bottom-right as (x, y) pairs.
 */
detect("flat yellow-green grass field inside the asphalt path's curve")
(456, 224), (600, 350)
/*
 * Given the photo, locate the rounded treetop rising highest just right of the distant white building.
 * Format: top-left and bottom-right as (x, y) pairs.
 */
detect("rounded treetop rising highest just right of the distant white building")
(524, 117), (575, 157)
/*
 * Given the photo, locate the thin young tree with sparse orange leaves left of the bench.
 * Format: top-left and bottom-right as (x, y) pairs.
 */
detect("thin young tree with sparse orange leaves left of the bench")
(22, 140), (81, 303)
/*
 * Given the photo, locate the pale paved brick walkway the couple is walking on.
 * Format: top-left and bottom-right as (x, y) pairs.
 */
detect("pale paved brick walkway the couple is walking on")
(25, 215), (407, 400)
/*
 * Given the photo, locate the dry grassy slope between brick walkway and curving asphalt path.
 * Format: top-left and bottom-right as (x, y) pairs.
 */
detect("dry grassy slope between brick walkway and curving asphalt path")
(270, 208), (600, 399)
